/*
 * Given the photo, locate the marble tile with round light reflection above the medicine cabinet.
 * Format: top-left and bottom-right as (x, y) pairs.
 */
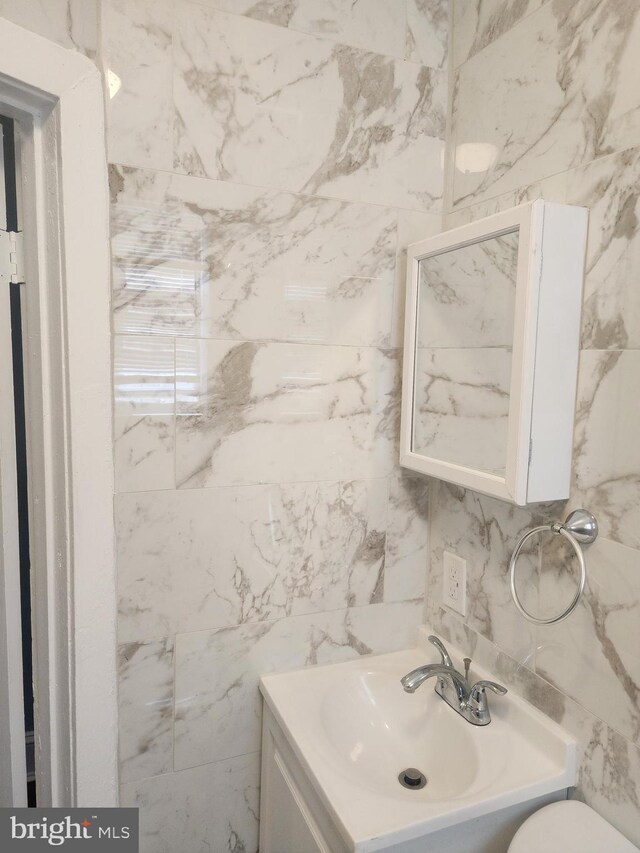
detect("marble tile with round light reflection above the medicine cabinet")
(452, 6), (584, 205)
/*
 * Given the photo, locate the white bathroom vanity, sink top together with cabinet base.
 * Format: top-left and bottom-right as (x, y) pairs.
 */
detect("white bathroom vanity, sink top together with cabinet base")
(260, 629), (575, 853)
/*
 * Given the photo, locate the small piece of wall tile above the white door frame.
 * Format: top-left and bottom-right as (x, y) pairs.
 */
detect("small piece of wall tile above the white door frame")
(0, 0), (99, 59)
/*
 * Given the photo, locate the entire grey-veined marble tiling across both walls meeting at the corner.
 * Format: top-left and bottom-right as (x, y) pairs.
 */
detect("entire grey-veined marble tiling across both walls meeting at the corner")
(6, 0), (640, 853)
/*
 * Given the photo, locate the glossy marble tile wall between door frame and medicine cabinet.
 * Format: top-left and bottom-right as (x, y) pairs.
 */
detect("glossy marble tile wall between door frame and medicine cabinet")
(101, 0), (447, 853)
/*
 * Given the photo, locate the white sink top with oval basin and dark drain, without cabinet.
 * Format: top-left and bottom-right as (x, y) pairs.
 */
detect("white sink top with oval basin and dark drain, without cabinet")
(260, 629), (576, 851)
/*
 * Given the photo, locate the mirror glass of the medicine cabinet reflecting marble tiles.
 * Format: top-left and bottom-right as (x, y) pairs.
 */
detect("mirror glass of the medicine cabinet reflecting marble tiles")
(411, 229), (518, 476)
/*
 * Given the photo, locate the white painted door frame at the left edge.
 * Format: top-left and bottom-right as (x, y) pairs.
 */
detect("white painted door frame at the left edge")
(0, 19), (117, 806)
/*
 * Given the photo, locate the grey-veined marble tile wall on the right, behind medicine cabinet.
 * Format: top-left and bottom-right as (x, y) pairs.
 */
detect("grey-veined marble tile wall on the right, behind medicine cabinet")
(427, 0), (640, 844)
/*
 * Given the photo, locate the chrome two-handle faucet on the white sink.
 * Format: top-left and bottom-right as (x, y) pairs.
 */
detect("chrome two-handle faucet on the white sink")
(400, 634), (507, 726)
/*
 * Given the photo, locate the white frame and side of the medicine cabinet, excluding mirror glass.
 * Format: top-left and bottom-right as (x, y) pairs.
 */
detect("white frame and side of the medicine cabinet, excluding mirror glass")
(400, 200), (588, 506)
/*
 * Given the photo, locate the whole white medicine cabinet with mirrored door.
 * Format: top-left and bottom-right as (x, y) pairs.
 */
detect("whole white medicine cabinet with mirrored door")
(400, 200), (588, 506)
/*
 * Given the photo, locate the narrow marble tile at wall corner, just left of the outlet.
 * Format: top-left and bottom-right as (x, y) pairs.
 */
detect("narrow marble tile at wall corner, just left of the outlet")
(384, 468), (429, 601)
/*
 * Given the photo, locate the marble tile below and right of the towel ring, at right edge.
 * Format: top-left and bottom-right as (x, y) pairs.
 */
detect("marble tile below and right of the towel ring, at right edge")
(536, 538), (640, 743)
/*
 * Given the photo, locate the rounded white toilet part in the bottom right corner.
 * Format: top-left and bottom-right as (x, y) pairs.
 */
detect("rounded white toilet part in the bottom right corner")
(509, 800), (638, 853)
